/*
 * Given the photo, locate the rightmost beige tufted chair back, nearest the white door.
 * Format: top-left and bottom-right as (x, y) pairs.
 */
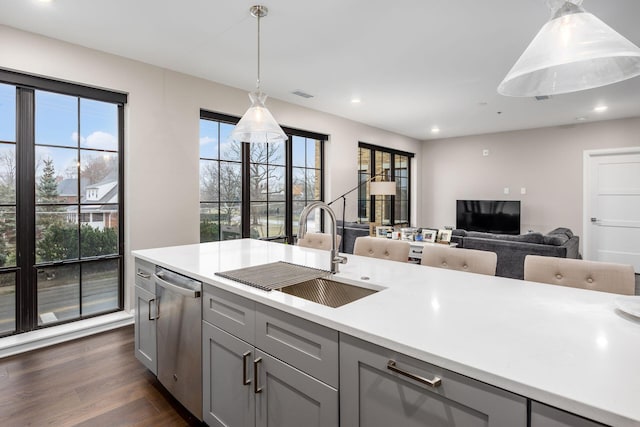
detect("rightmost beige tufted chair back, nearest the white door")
(524, 255), (635, 295)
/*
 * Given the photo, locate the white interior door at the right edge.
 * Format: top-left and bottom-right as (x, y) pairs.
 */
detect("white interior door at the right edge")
(583, 147), (640, 273)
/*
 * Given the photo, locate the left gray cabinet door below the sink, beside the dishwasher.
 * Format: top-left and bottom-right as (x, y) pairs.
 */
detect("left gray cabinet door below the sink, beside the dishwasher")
(202, 322), (255, 427)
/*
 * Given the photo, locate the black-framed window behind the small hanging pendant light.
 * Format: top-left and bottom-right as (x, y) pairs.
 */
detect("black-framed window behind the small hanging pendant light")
(200, 111), (328, 243)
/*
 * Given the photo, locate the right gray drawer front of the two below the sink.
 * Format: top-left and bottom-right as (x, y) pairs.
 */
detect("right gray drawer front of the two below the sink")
(255, 304), (339, 388)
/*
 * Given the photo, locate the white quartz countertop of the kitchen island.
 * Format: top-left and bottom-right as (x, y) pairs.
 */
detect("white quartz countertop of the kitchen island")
(133, 239), (640, 426)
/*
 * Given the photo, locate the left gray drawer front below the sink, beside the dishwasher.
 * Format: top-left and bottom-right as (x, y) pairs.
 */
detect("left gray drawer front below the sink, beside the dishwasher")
(202, 284), (256, 344)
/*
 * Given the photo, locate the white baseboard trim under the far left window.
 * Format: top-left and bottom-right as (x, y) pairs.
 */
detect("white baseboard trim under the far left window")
(0, 311), (134, 358)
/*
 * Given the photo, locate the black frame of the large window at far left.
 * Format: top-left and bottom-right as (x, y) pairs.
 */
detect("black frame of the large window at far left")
(0, 68), (128, 336)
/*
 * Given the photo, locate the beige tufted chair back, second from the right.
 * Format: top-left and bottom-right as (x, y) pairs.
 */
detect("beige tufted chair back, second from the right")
(420, 245), (498, 276)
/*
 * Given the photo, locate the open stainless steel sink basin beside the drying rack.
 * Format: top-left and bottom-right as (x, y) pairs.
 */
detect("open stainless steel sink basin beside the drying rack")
(278, 277), (378, 308)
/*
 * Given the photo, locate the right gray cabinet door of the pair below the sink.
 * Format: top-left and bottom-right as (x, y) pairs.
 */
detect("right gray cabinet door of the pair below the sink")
(255, 350), (339, 427)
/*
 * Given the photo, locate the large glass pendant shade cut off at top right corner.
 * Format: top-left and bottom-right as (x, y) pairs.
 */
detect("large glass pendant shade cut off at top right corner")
(498, 0), (640, 96)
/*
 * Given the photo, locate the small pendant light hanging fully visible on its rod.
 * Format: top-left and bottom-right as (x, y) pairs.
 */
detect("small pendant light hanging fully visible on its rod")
(230, 5), (288, 143)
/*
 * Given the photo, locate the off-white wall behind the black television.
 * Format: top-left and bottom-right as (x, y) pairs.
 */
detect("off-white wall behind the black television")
(419, 117), (640, 244)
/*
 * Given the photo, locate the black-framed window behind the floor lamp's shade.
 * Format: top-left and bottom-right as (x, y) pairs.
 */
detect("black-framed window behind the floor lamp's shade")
(358, 142), (413, 225)
